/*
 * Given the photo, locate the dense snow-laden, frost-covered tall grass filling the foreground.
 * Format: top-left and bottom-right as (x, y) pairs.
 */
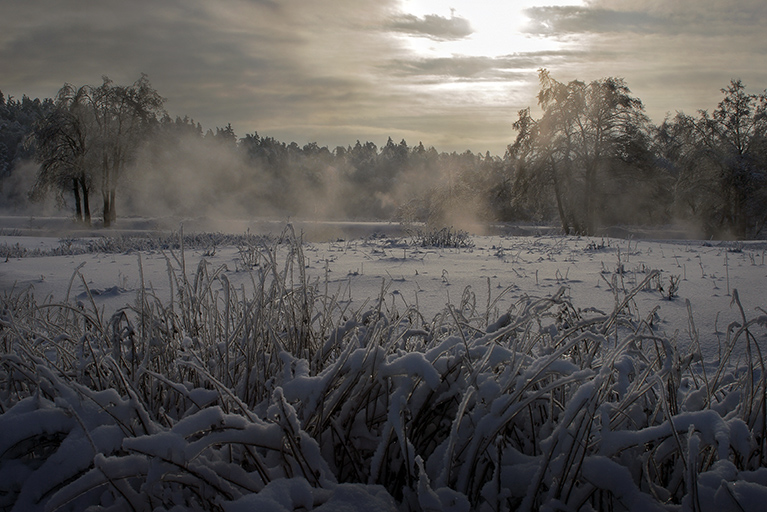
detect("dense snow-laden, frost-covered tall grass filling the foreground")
(0, 230), (767, 511)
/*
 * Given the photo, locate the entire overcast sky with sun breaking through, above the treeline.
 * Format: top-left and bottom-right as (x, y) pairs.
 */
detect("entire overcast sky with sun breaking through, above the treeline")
(0, 0), (767, 155)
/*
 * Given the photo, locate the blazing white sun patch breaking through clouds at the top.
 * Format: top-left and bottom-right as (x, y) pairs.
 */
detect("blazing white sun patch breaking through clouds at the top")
(401, 0), (583, 57)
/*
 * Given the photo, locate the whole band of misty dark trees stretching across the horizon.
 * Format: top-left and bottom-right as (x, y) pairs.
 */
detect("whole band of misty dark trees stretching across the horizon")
(0, 70), (767, 238)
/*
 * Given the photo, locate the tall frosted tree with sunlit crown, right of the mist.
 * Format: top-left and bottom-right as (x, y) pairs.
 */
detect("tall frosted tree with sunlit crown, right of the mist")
(507, 69), (651, 234)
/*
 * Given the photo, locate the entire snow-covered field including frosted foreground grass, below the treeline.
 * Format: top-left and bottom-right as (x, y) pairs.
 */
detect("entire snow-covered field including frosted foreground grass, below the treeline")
(0, 218), (767, 511)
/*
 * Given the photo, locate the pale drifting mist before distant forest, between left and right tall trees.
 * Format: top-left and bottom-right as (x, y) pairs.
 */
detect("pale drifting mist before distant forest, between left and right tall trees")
(118, 129), (500, 236)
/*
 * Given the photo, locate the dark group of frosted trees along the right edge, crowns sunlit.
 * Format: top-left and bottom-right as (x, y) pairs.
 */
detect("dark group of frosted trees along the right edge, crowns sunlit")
(505, 70), (767, 238)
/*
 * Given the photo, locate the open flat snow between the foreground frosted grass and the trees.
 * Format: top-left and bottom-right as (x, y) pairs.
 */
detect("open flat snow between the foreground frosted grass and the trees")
(0, 221), (767, 360)
